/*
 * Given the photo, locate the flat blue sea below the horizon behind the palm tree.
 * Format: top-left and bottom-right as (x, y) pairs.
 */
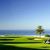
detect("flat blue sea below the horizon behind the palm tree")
(0, 30), (50, 35)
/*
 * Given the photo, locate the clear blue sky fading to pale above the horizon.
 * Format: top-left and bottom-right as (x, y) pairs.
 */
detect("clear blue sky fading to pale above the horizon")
(0, 0), (50, 30)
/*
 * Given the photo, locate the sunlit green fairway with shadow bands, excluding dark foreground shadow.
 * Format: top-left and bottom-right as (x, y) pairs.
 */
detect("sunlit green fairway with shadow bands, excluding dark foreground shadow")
(0, 36), (50, 50)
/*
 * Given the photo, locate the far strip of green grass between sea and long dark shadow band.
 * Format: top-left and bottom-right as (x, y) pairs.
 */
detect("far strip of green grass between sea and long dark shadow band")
(0, 37), (43, 42)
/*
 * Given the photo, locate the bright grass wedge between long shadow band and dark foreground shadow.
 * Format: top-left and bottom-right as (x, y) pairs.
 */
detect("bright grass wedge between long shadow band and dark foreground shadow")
(5, 43), (50, 49)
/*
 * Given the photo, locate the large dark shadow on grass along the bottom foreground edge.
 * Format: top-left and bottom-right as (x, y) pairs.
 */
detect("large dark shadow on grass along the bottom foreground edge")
(0, 45), (47, 50)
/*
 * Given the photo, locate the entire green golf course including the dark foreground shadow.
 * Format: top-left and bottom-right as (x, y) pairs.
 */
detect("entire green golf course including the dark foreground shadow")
(0, 36), (50, 50)
